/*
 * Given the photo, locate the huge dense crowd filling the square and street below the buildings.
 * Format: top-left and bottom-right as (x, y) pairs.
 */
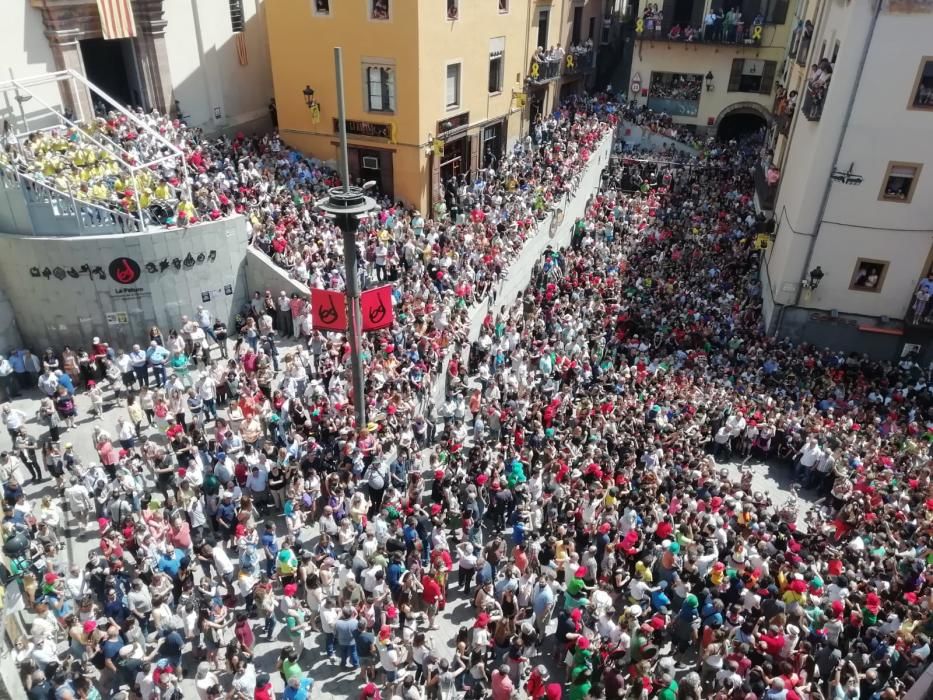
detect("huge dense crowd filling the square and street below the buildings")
(0, 89), (933, 700)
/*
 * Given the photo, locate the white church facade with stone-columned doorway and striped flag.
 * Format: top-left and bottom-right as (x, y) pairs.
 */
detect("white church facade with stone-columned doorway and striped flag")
(0, 0), (272, 132)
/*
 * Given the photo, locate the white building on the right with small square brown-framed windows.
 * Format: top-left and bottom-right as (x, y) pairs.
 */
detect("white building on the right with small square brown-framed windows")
(762, 0), (933, 357)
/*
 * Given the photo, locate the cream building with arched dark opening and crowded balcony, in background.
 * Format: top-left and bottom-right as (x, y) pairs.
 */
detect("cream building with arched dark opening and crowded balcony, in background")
(626, 0), (796, 137)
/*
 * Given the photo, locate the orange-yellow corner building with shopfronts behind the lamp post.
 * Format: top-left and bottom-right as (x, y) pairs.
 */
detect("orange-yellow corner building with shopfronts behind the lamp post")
(266, 0), (601, 213)
